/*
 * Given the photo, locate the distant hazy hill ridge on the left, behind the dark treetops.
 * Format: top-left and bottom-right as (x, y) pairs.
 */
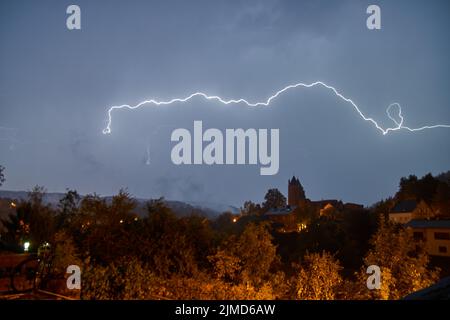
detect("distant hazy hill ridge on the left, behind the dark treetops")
(0, 190), (239, 218)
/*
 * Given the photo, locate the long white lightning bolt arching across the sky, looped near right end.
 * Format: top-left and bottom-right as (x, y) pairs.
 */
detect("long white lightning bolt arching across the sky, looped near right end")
(103, 81), (450, 135)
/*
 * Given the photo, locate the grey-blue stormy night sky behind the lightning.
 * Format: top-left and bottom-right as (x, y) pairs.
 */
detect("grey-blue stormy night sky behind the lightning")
(0, 0), (450, 206)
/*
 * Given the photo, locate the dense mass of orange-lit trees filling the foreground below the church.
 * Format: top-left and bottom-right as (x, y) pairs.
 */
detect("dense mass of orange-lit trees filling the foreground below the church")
(1, 171), (450, 299)
